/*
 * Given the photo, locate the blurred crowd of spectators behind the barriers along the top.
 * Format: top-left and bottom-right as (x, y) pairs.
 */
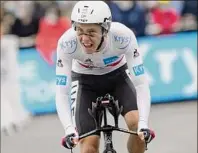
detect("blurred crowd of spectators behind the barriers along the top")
(1, 0), (197, 49)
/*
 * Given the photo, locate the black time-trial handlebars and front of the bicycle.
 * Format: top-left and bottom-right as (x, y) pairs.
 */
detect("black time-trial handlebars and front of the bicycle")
(80, 94), (137, 153)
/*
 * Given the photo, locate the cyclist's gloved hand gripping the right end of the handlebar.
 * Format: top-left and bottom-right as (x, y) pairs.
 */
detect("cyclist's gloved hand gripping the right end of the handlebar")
(138, 129), (155, 143)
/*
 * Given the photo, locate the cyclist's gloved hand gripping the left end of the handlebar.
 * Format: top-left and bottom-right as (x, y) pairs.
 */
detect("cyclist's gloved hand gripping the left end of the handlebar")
(62, 128), (79, 149)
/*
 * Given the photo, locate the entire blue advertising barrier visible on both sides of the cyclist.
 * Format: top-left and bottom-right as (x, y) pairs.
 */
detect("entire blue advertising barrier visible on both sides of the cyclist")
(19, 32), (197, 114)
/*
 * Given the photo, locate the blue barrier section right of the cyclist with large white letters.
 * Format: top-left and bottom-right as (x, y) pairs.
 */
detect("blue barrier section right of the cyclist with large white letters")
(138, 32), (197, 103)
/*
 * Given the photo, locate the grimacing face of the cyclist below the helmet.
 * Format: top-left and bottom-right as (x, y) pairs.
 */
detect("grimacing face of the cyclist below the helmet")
(76, 24), (102, 54)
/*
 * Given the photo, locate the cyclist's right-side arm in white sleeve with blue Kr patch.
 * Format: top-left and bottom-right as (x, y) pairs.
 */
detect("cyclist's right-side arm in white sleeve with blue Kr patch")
(125, 31), (151, 128)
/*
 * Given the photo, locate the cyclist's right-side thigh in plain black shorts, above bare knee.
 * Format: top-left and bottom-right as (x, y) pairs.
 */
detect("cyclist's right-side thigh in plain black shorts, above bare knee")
(114, 68), (137, 116)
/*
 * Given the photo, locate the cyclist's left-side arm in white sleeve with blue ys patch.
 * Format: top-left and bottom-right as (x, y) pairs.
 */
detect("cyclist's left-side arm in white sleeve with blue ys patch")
(56, 40), (72, 132)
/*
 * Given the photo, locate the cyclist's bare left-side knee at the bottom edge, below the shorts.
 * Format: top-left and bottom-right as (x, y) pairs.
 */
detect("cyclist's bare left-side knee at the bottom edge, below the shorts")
(80, 136), (99, 153)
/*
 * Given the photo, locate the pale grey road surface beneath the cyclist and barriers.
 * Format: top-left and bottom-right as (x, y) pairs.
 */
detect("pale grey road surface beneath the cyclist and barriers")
(1, 101), (197, 153)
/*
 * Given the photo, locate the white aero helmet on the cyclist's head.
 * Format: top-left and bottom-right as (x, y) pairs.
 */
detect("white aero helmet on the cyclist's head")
(71, 1), (112, 31)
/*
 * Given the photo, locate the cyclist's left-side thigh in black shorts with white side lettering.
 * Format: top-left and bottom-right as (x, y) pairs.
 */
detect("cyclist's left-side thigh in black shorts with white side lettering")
(71, 72), (98, 135)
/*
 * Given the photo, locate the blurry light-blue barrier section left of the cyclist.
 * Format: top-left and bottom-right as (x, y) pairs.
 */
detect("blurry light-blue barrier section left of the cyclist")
(19, 49), (56, 114)
